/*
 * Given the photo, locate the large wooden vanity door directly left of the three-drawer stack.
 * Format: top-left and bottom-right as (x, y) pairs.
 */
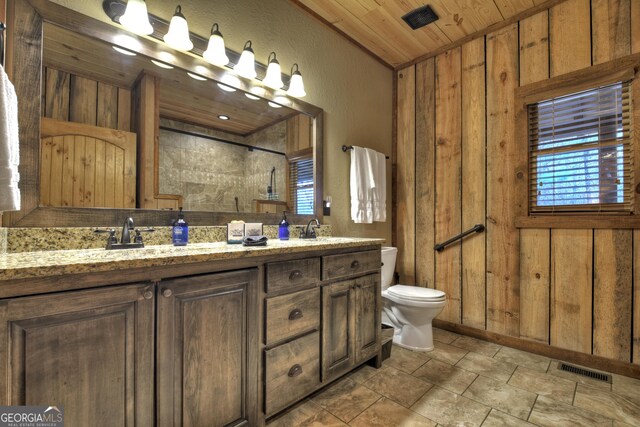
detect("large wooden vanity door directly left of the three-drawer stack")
(156, 269), (258, 427)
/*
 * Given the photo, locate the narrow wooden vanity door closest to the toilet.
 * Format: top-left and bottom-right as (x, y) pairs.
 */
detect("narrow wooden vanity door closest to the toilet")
(355, 274), (382, 363)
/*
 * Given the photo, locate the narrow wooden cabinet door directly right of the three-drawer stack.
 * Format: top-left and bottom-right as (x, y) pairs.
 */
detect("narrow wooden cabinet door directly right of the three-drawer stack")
(322, 280), (355, 381)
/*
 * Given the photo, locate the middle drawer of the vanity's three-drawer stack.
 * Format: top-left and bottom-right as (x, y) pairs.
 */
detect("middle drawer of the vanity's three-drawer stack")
(265, 288), (320, 345)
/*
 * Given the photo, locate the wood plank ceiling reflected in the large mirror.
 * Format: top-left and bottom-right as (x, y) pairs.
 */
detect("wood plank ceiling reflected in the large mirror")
(43, 23), (297, 136)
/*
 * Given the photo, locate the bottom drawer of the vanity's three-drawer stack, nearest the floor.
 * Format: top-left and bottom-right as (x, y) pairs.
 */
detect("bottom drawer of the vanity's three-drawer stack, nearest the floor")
(265, 332), (320, 416)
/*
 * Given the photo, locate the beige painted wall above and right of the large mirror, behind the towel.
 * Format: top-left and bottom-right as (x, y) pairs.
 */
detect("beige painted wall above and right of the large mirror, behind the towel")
(53, 0), (393, 243)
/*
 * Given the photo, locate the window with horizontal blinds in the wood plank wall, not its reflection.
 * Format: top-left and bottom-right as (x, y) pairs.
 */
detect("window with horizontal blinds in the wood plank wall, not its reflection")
(528, 82), (633, 213)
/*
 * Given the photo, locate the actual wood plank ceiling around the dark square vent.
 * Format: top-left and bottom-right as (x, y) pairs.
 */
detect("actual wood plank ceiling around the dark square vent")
(291, 0), (547, 68)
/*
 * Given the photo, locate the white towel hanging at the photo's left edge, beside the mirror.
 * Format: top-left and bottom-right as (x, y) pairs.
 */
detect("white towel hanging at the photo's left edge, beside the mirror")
(0, 66), (20, 212)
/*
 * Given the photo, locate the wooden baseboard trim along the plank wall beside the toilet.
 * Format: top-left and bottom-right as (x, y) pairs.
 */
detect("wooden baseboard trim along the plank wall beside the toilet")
(433, 319), (640, 379)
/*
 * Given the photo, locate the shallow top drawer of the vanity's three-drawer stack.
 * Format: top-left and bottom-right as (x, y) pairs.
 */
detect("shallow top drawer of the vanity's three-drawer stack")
(266, 258), (320, 293)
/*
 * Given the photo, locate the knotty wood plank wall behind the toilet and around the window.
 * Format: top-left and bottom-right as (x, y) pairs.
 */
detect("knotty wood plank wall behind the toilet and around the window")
(394, 0), (640, 363)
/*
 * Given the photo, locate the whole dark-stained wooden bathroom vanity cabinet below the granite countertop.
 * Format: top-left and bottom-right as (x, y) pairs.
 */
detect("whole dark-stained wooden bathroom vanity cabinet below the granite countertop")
(0, 239), (380, 426)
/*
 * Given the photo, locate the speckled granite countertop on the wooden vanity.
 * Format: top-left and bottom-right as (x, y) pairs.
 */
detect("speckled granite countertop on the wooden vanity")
(0, 237), (384, 281)
